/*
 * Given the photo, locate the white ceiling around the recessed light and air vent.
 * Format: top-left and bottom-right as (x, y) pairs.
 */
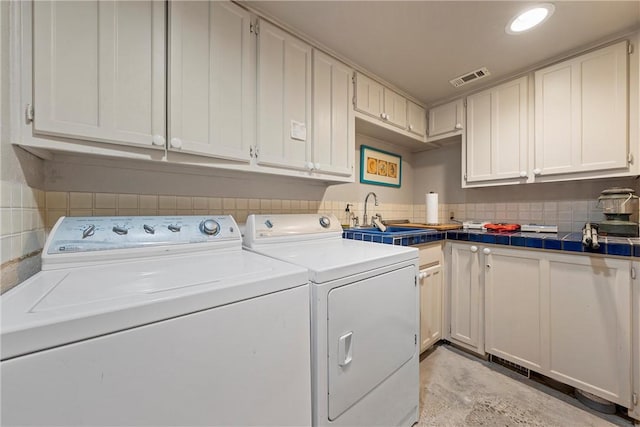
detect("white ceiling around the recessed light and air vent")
(244, 1), (640, 105)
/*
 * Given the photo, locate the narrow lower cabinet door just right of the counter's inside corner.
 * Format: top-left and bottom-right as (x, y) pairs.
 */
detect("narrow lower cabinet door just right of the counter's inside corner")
(449, 244), (484, 354)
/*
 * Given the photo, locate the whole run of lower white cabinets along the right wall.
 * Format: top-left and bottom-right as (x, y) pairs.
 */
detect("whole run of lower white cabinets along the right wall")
(460, 243), (640, 412)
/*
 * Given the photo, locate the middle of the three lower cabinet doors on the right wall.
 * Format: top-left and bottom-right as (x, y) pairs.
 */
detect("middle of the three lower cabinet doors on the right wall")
(484, 248), (546, 372)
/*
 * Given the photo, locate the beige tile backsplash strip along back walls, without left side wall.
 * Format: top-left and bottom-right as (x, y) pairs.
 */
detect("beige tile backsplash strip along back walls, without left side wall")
(38, 192), (604, 231)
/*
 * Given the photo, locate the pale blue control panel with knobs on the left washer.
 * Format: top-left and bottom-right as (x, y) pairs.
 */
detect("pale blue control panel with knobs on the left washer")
(46, 215), (242, 254)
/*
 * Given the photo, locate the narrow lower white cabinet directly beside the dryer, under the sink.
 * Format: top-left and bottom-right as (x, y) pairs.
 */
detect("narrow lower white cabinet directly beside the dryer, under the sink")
(419, 244), (444, 353)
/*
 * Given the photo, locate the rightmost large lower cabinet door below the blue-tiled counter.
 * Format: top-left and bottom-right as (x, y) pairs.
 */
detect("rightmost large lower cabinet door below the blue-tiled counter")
(544, 254), (631, 407)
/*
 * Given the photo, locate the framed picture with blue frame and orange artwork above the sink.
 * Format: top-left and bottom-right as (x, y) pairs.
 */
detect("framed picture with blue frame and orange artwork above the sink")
(360, 145), (402, 188)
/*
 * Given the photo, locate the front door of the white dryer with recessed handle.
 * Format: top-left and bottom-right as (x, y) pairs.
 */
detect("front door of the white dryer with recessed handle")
(327, 266), (418, 421)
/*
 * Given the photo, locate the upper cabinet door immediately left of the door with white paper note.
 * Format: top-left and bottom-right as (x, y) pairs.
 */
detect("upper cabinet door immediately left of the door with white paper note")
(169, 1), (255, 162)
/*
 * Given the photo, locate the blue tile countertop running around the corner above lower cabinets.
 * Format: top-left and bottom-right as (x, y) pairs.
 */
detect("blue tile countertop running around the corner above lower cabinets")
(342, 229), (640, 257)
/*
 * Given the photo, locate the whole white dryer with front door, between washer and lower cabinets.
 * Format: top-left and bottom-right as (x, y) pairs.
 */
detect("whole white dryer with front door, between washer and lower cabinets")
(244, 214), (420, 426)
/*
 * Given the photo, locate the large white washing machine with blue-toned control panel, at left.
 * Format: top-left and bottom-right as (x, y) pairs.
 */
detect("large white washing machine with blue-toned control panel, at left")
(0, 216), (311, 426)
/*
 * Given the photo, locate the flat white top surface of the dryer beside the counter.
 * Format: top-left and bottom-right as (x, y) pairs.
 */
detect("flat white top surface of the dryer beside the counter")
(252, 238), (418, 283)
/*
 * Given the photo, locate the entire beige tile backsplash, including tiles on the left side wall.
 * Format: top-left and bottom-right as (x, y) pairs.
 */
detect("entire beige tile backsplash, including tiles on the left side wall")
(0, 186), (632, 291)
